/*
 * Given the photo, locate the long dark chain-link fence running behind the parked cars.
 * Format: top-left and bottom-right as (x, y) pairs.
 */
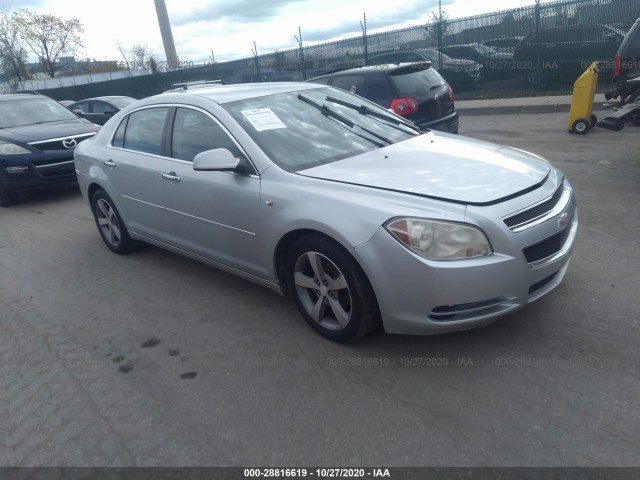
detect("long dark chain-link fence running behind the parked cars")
(40, 0), (640, 99)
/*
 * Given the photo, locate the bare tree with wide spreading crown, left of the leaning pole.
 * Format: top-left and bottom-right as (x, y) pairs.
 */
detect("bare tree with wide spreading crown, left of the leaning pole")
(16, 9), (84, 78)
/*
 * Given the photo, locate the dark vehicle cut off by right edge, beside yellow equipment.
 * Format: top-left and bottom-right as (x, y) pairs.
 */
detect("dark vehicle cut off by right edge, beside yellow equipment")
(605, 18), (640, 105)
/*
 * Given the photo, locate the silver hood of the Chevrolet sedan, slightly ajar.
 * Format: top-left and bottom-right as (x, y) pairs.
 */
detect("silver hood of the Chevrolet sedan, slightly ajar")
(298, 132), (552, 205)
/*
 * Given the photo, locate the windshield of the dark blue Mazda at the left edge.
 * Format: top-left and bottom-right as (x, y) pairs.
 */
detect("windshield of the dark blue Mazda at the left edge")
(0, 97), (78, 128)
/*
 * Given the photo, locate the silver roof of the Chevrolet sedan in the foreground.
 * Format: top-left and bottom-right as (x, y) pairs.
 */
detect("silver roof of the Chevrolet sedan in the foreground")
(142, 82), (326, 104)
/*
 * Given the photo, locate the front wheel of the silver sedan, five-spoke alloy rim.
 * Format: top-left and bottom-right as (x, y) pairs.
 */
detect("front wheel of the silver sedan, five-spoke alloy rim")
(286, 235), (380, 342)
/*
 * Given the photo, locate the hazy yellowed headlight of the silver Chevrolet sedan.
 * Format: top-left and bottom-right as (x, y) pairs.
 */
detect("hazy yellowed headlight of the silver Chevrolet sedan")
(385, 218), (493, 260)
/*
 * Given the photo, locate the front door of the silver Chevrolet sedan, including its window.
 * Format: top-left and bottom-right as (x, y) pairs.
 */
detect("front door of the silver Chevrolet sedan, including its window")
(156, 107), (267, 278)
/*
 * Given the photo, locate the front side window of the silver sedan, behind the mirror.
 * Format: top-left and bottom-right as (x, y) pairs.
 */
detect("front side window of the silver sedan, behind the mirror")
(171, 108), (240, 162)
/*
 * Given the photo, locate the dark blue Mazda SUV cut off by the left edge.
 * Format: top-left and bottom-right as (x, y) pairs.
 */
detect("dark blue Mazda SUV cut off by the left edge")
(0, 93), (100, 207)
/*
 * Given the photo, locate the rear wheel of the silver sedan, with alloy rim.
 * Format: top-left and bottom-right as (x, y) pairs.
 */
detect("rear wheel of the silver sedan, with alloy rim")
(91, 190), (139, 255)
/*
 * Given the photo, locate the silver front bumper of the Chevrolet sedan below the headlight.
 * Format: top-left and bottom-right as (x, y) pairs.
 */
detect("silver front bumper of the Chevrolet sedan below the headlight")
(355, 178), (578, 335)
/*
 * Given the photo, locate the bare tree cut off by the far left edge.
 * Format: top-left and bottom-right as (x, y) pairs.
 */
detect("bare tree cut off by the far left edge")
(0, 10), (29, 89)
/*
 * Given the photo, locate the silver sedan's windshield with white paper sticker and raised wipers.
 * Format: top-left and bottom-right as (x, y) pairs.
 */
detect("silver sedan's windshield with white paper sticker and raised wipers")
(223, 87), (418, 172)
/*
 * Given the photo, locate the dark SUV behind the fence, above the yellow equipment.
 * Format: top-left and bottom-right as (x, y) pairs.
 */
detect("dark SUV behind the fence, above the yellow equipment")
(514, 25), (624, 85)
